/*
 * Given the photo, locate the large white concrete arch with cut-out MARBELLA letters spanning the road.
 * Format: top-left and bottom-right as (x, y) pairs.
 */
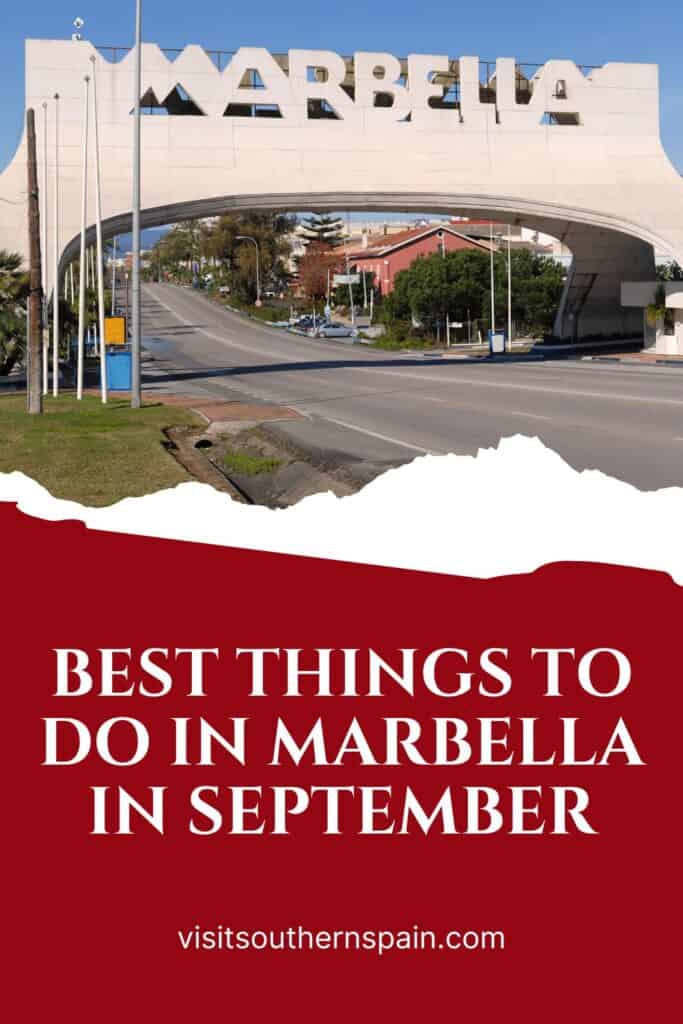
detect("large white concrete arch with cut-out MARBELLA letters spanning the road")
(0, 40), (683, 339)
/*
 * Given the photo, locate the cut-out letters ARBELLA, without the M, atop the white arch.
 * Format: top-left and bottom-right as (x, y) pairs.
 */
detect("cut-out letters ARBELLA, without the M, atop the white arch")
(174, 47), (589, 128)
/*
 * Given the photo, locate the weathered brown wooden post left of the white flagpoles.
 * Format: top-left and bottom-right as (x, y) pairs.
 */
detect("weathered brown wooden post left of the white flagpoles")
(26, 110), (43, 416)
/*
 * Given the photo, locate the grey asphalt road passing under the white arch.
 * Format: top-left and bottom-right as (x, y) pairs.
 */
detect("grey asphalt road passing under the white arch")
(142, 285), (683, 489)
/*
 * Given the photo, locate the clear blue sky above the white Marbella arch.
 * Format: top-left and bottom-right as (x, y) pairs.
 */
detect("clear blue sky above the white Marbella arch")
(0, 0), (683, 173)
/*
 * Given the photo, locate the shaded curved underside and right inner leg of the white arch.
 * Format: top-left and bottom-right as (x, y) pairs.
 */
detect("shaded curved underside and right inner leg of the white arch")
(60, 191), (667, 340)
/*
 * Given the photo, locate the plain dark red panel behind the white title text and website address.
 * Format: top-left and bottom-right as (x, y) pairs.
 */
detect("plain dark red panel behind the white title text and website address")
(0, 506), (683, 1024)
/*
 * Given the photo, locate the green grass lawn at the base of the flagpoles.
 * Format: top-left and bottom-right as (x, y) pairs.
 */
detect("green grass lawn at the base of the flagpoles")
(0, 394), (200, 506)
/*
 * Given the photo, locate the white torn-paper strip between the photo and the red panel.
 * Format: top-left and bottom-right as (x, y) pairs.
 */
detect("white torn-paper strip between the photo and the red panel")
(0, 436), (683, 584)
